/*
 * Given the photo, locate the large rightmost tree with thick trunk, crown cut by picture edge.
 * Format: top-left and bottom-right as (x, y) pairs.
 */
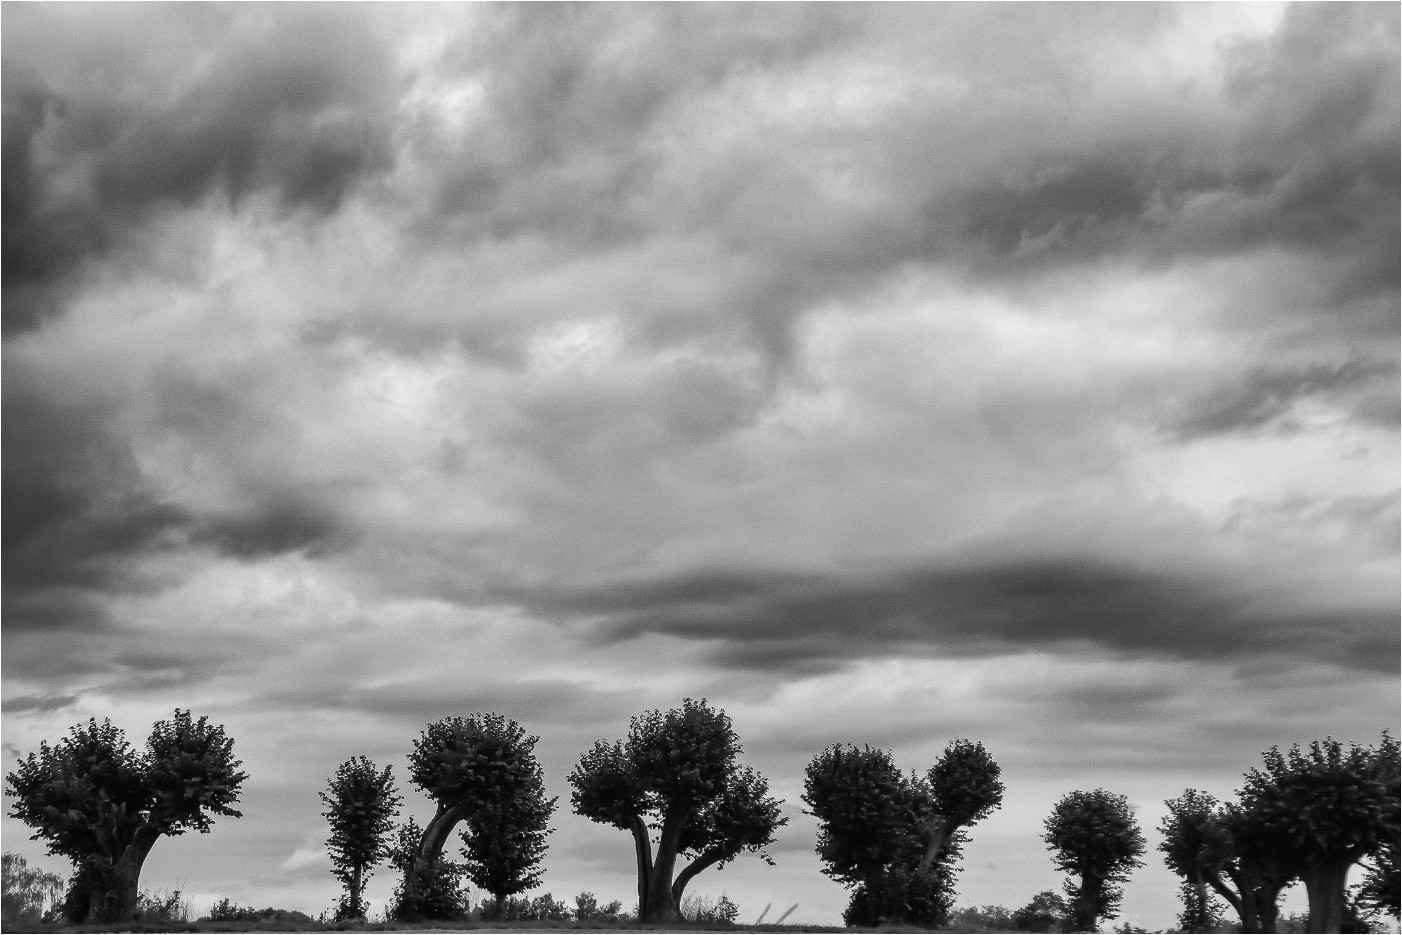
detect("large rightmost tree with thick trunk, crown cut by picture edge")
(1235, 732), (1399, 932)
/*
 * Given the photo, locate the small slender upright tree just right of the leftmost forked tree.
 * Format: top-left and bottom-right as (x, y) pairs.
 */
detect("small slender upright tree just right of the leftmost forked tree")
(320, 757), (404, 921)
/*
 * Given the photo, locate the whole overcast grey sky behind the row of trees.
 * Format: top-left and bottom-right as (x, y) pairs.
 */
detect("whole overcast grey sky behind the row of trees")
(3, 3), (1399, 927)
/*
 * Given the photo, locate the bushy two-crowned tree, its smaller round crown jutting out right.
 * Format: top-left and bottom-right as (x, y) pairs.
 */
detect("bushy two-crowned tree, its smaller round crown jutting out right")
(803, 740), (1004, 925)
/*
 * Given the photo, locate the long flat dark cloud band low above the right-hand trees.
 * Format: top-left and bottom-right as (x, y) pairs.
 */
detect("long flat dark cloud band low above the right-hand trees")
(527, 559), (1398, 673)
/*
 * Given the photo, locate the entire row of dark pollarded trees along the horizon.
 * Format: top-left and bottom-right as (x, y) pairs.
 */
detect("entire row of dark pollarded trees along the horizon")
(6, 699), (1399, 932)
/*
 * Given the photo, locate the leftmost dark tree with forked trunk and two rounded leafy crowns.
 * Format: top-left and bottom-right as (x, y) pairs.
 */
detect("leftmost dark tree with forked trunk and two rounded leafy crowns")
(6, 709), (247, 922)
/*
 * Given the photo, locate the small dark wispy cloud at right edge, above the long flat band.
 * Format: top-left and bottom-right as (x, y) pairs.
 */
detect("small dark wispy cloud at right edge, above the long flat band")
(1164, 360), (1398, 442)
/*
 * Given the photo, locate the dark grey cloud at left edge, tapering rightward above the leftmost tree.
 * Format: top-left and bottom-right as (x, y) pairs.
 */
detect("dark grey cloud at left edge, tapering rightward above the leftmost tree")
(0, 357), (353, 634)
